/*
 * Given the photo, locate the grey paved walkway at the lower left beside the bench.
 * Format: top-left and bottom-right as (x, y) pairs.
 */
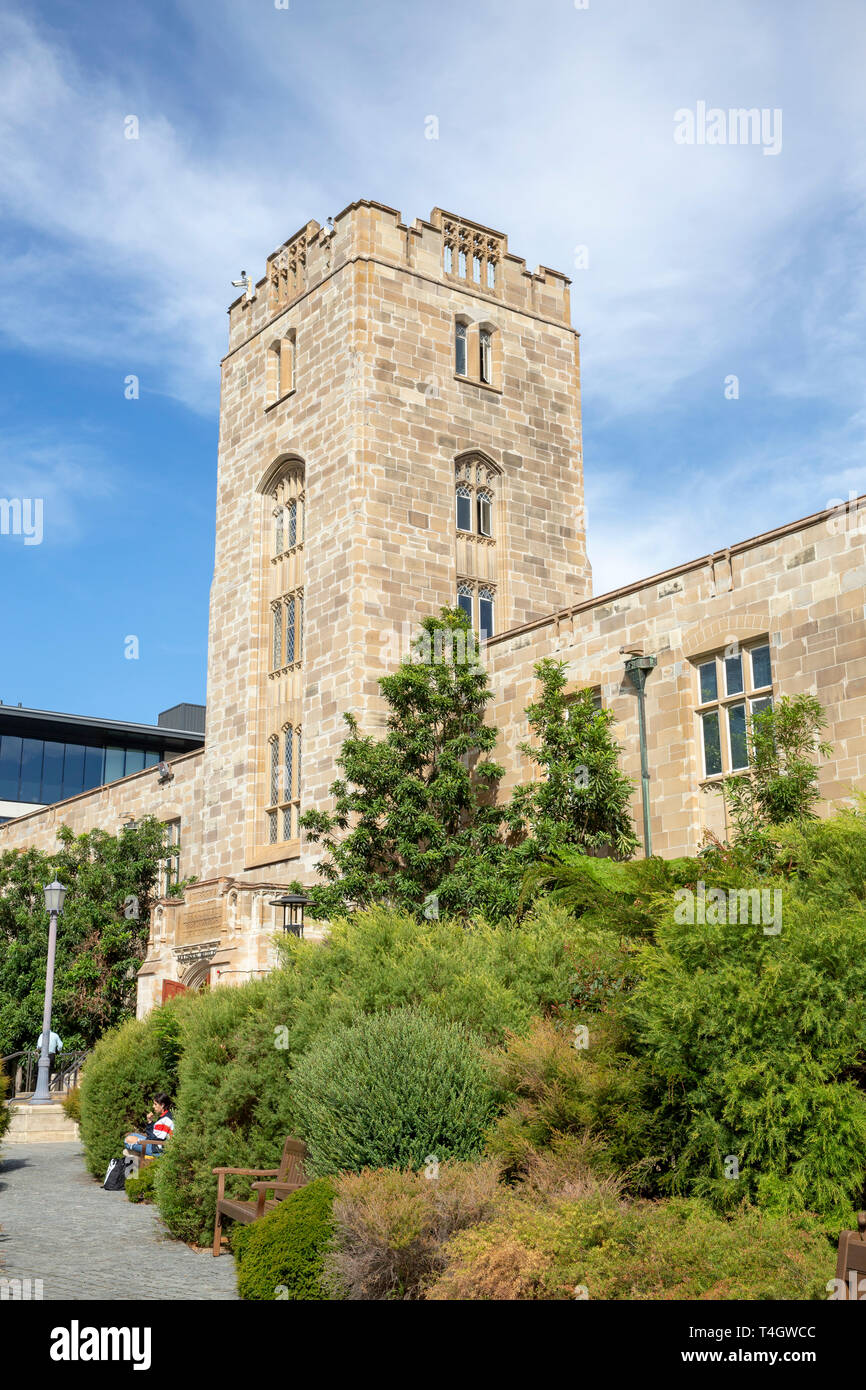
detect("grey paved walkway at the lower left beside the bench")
(0, 1143), (238, 1301)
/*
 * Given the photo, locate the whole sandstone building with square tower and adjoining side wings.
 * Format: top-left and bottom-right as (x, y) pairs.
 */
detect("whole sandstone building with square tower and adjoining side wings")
(0, 200), (866, 1012)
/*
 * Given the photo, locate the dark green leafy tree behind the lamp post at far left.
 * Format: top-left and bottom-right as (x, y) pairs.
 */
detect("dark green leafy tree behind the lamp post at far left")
(0, 817), (174, 1054)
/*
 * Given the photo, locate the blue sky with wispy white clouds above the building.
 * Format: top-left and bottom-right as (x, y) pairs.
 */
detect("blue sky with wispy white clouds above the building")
(0, 0), (866, 721)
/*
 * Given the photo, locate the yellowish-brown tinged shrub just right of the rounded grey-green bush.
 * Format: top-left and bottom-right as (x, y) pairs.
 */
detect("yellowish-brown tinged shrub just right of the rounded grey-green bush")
(488, 1019), (660, 1184)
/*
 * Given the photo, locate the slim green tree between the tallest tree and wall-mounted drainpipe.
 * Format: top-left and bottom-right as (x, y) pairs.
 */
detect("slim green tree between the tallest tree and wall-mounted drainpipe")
(513, 657), (638, 859)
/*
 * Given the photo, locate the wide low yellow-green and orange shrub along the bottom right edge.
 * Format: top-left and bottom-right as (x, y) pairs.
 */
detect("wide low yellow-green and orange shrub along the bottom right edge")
(427, 1190), (834, 1301)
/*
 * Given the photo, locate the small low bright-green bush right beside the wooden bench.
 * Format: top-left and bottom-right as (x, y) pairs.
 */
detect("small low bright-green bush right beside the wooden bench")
(232, 1177), (334, 1301)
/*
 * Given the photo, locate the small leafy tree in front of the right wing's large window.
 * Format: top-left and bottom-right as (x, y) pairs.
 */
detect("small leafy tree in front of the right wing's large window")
(719, 694), (833, 852)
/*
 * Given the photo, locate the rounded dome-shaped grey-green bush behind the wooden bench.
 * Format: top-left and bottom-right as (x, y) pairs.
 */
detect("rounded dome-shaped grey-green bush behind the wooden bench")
(292, 1008), (492, 1176)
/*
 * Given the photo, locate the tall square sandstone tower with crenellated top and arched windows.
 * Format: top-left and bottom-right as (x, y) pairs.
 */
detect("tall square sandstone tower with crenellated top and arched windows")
(200, 200), (591, 883)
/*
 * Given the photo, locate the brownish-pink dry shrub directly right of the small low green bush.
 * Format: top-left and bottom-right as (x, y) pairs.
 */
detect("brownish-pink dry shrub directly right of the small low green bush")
(327, 1161), (499, 1300)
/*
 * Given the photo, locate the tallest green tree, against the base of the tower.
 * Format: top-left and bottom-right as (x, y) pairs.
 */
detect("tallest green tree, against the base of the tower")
(302, 609), (505, 917)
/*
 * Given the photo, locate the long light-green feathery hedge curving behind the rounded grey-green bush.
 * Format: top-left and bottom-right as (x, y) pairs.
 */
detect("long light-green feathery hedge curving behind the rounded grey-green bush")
(156, 904), (586, 1244)
